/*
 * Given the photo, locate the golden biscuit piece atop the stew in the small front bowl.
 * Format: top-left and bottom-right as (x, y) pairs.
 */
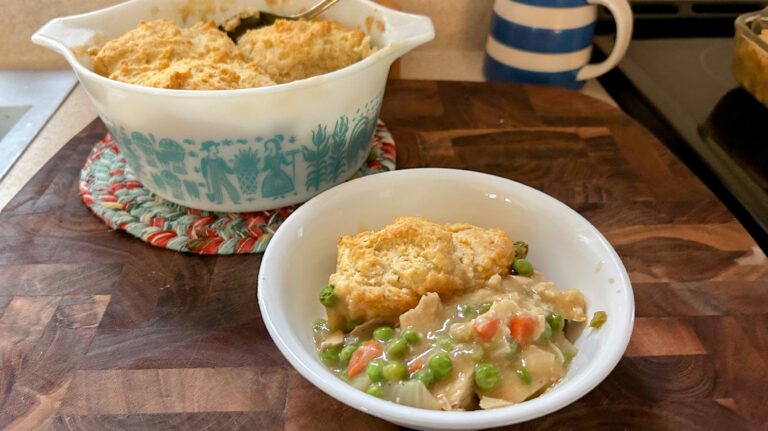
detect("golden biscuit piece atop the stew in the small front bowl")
(328, 217), (514, 325)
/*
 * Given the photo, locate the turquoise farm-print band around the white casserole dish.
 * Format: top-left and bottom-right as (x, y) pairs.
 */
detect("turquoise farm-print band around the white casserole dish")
(108, 94), (382, 205)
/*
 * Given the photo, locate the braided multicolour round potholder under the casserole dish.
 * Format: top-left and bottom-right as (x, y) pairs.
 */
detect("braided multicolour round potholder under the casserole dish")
(80, 120), (395, 255)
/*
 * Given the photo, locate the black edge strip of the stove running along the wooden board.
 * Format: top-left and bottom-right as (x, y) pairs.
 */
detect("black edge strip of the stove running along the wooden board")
(592, 49), (768, 253)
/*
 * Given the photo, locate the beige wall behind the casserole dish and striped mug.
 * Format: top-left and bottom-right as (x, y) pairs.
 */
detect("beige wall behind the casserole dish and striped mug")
(0, 0), (493, 79)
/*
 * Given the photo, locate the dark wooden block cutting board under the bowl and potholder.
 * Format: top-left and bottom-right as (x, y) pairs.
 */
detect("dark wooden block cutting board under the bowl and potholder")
(0, 81), (768, 431)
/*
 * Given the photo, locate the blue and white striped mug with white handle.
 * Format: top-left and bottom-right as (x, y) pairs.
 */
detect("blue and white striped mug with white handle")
(483, 0), (632, 89)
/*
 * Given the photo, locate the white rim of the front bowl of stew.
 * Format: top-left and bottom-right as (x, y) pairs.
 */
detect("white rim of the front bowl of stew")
(257, 168), (635, 429)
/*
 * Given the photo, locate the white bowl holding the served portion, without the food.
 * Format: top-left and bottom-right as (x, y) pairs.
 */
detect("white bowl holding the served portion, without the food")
(258, 169), (634, 429)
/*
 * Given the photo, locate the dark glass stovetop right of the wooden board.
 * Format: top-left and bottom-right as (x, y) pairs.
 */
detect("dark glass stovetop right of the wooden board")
(596, 36), (768, 249)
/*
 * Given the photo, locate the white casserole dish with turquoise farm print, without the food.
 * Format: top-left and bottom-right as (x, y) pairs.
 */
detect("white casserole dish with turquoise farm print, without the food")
(32, 0), (434, 212)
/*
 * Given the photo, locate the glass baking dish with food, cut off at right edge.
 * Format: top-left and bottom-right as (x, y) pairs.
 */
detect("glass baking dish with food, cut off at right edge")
(733, 8), (768, 107)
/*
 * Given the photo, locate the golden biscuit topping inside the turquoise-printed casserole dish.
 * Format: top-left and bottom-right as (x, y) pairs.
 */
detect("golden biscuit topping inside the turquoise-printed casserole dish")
(88, 19), (371, 90)
